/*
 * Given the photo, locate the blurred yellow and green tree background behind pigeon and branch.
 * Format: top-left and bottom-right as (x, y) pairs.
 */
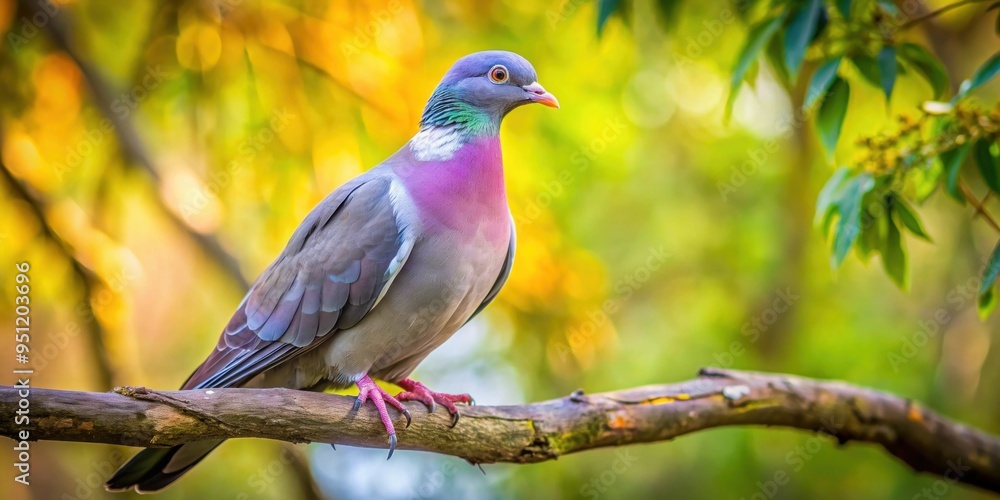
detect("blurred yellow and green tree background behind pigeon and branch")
(0, 0), (1000, 499)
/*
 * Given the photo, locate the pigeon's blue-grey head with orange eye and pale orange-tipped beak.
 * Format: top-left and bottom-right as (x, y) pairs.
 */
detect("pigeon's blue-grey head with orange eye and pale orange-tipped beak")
(420, 50), (559, 134)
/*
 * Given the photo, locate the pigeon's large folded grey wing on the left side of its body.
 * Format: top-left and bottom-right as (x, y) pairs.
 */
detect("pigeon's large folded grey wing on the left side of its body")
(182, 176), (414, 389)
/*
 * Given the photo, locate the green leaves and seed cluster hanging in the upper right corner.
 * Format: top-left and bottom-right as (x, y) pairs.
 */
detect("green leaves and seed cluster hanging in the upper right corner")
(599, 0), (1000, 316)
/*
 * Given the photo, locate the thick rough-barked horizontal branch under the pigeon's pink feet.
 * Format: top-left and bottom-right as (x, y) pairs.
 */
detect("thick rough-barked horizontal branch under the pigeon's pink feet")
(0, 369), (1000, 492)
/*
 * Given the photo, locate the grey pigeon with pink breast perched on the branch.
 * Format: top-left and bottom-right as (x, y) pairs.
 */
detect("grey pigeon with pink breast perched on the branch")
(105, 51), (559, 492)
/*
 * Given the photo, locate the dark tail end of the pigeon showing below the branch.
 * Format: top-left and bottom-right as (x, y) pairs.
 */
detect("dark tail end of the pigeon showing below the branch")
(104, 440), (222, 493)
